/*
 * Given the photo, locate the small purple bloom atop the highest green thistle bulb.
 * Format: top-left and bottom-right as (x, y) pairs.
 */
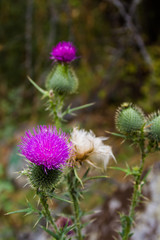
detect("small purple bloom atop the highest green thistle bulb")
(50, 41), (77, 63)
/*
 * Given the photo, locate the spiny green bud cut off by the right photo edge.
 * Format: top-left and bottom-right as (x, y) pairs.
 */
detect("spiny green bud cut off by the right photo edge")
(146, 111), (160, 142)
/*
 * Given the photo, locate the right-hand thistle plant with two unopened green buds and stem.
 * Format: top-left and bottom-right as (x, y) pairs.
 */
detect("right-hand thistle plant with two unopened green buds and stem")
(112, 103), (160, 240)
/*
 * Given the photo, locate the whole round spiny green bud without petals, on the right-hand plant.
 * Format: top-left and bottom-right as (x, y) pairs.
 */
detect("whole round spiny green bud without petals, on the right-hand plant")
(115, 103), (145, 134)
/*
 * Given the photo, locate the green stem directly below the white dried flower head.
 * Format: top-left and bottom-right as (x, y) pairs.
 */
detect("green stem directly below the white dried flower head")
(68, 169), (83, 240)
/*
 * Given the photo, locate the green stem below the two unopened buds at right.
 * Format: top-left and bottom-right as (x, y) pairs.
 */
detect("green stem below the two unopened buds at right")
(122, 140), (146, 240)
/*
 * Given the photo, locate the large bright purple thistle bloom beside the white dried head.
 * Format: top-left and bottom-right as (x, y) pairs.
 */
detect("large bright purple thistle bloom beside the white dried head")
(19, 126), (72, 169)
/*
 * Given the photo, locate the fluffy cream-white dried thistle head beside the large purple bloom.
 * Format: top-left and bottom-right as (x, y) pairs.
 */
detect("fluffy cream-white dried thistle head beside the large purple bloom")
(71, 127), (115, 169)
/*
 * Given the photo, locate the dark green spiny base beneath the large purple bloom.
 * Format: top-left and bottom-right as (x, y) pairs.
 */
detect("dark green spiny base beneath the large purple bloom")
(28, 164), (62, 192)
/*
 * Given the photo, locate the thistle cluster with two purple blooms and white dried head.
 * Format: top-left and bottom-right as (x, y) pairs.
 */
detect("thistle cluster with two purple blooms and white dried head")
(8, 42), (114, 240)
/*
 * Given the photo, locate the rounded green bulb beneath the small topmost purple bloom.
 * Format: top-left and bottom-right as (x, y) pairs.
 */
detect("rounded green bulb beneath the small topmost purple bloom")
(46, 63), (78, 95)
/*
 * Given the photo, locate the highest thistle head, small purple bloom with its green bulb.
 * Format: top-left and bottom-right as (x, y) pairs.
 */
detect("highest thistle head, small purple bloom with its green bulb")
(46, 42), (78, 95)
